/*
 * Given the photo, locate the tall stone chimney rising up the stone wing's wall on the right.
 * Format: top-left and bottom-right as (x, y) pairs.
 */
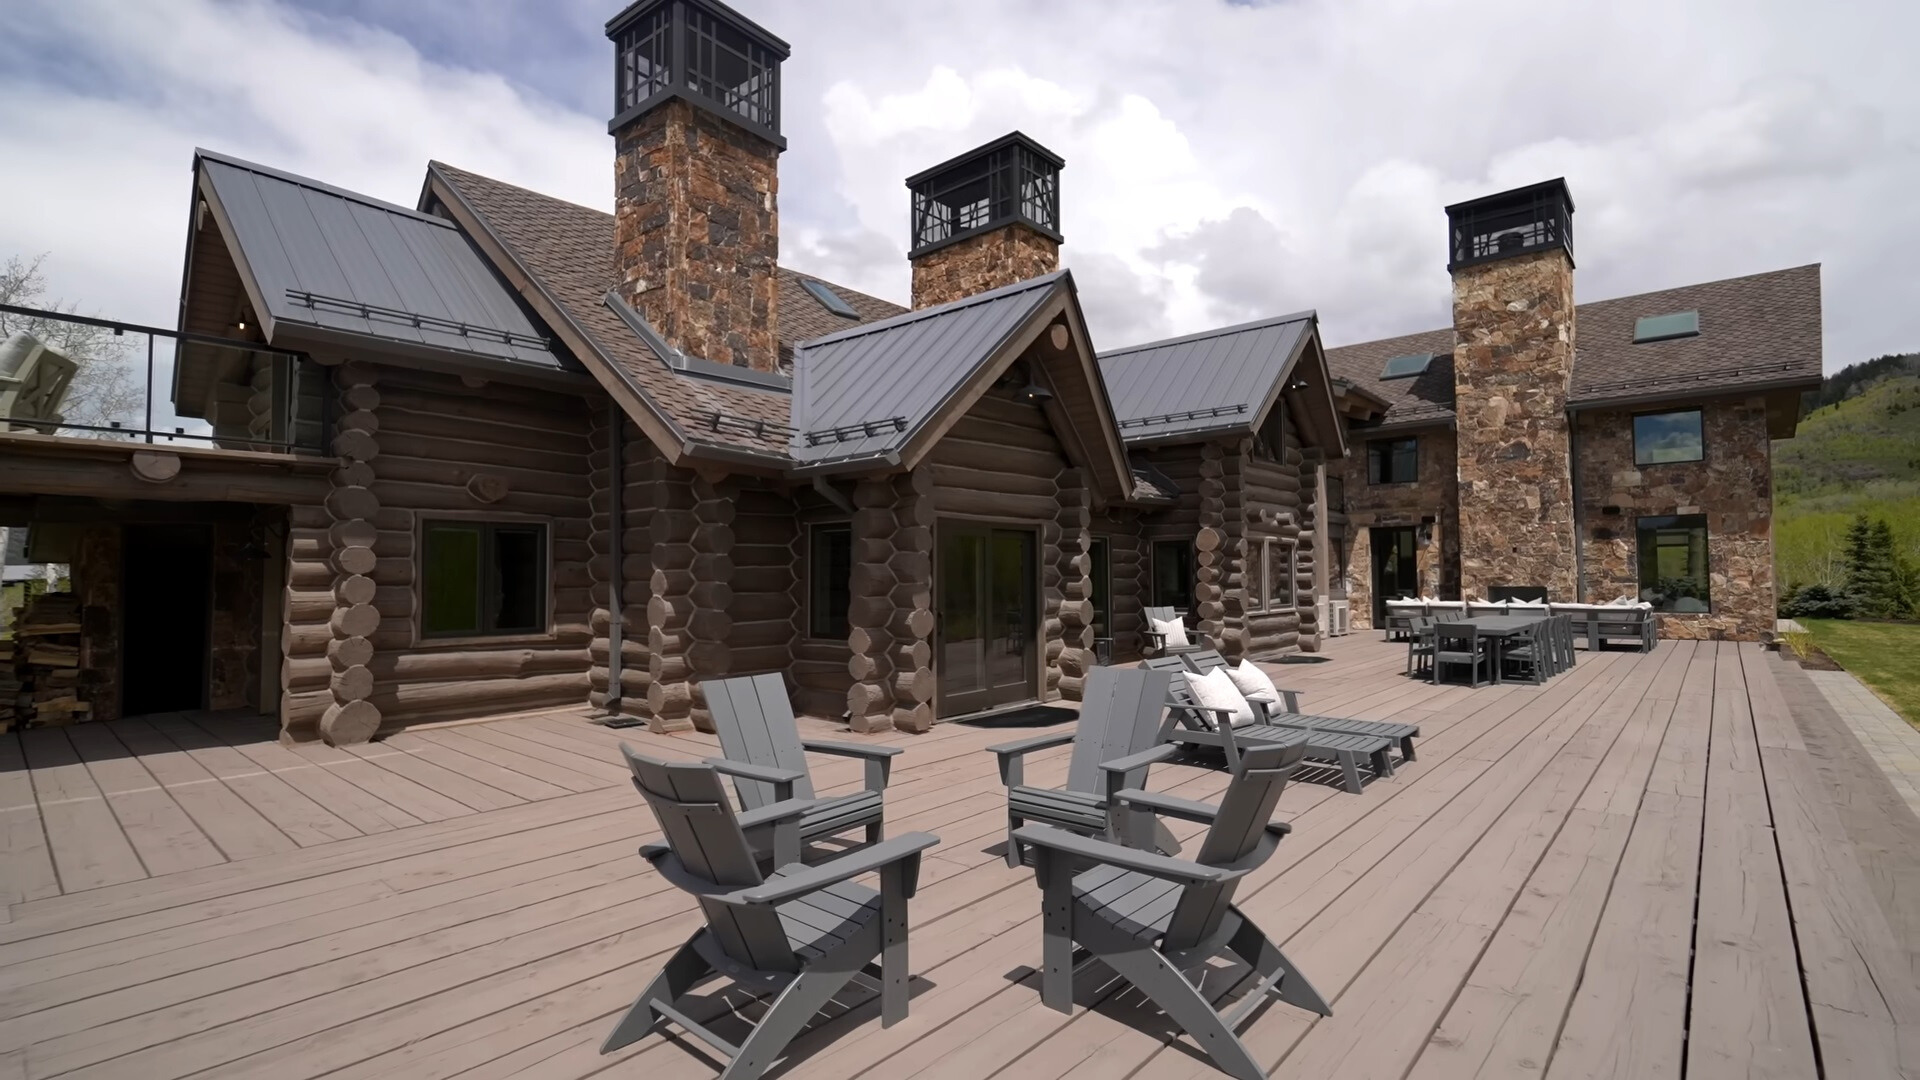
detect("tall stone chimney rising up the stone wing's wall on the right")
(1446, 181), (1578, 601)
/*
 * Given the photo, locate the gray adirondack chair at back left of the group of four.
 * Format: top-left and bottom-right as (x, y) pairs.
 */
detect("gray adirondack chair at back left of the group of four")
(701, 675), (900, 863)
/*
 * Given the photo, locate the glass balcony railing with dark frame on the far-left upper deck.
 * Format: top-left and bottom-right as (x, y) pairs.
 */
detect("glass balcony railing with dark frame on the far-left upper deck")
(0, 304), (330, 454)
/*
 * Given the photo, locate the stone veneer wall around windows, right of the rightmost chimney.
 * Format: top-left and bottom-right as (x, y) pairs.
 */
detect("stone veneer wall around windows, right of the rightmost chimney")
(1578, 396), (1774, 642)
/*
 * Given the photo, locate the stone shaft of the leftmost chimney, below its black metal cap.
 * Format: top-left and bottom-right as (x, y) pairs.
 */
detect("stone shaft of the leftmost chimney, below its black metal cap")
(614, 102), (780, 371)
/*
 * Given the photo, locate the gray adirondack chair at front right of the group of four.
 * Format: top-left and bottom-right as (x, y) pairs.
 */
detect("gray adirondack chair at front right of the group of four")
(1020, 744), (1332, 1080)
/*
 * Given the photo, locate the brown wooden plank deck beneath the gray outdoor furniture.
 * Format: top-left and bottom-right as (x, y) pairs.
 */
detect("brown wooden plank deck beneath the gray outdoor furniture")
(0, 636), (1920, 1080)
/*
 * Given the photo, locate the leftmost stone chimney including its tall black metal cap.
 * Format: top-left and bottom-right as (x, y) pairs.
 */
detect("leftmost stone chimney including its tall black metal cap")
(607, 0), (789, 371)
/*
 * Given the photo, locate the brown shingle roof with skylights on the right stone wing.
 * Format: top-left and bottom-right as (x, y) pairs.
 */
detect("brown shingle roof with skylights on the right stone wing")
(1327, 263), (1820, 425)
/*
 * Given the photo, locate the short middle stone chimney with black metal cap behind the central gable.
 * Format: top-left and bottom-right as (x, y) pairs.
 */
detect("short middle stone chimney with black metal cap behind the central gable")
(906, 131), (1066, 309)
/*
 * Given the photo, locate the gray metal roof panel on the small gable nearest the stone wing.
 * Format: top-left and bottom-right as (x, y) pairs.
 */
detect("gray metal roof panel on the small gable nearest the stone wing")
(1100, 311), (1313, 442)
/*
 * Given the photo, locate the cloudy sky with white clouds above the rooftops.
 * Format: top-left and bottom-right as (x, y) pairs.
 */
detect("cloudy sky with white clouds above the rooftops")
(0, 0), (1920, 369)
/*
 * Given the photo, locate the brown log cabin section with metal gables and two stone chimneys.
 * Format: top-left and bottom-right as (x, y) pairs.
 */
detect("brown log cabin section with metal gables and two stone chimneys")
(0, 0), (1818, 744)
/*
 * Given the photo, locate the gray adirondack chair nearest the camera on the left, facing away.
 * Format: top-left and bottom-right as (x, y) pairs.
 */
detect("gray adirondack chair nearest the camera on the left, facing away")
(601, 744), (941, 1080)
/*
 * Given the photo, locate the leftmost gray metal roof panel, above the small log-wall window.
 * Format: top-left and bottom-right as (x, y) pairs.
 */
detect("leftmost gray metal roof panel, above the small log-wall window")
(198, 152), (572, 369)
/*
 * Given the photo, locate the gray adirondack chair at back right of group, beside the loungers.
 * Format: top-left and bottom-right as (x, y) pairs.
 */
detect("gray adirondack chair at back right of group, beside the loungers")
(987, 667), (1181, 867)
